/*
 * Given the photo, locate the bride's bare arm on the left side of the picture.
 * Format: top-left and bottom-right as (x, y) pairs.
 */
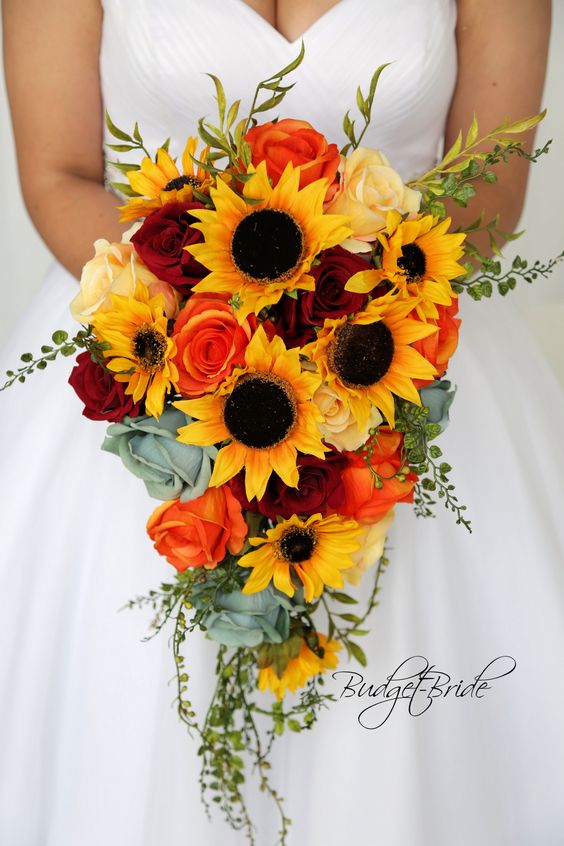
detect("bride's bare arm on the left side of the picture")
(2, 0), (125, 276)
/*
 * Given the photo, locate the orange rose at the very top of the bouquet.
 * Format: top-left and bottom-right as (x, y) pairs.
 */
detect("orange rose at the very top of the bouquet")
(245, 118), (341, 196)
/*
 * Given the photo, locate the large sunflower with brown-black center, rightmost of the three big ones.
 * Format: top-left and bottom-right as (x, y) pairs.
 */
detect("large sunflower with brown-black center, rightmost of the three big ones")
(302, 292), (438, 428)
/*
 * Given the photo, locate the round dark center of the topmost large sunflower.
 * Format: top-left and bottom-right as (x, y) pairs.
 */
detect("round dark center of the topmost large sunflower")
(231, 209), (304, 285)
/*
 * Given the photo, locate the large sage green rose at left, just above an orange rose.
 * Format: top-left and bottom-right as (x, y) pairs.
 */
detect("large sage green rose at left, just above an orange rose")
(102, 408), (217, 502)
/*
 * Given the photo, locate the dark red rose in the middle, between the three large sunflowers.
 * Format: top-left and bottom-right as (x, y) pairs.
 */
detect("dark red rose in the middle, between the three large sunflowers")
(275, 247), (369, 347)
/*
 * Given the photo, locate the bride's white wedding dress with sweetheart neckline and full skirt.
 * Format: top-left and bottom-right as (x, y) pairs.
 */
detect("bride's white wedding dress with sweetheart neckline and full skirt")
(0, 0), (564, 846)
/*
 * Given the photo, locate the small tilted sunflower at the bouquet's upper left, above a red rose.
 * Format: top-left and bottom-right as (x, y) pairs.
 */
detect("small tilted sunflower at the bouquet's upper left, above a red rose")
(119, 138), (211, 222)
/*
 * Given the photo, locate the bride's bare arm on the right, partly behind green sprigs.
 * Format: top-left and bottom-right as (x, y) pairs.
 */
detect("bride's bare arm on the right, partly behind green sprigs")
(445, 0), (551, 252)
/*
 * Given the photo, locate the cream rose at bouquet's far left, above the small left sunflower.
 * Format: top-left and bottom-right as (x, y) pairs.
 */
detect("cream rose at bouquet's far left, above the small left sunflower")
(70, 245), (179, 324)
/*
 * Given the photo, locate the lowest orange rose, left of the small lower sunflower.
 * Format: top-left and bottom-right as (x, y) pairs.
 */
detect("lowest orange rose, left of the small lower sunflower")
(147, 486), (247, 573)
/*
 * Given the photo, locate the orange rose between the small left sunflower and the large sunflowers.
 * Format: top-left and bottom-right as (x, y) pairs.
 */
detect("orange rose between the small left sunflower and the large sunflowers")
(172, 294), (254, 397)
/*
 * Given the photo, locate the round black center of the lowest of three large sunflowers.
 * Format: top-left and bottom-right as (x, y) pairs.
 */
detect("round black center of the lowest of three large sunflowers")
(223, 373), (297, 449)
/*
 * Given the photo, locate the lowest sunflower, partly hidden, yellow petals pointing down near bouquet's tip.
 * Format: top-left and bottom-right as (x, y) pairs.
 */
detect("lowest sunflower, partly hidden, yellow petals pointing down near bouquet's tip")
(258, 632), (342, 700)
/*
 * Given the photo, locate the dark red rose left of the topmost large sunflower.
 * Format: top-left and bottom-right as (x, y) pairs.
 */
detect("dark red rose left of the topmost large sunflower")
(131, 203), (208, 294)
